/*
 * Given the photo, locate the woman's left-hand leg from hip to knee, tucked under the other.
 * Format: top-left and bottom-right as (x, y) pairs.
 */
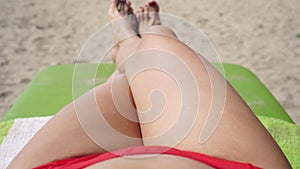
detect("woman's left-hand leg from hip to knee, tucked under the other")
(8, 0), (142, 169)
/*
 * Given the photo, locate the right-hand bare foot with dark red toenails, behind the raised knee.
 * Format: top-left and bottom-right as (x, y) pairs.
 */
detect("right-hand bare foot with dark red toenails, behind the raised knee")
(136, 1), (161, 34)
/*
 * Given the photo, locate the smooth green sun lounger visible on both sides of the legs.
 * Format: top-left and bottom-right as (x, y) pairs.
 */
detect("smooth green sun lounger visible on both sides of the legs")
(1, 64), (293, 123)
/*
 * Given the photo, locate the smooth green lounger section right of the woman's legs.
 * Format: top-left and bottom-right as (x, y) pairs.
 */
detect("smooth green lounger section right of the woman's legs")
(214, 64), (294, 123)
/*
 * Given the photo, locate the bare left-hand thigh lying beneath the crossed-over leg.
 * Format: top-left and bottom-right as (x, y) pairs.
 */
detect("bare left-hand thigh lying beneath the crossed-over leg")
(9, 75), (142, 168)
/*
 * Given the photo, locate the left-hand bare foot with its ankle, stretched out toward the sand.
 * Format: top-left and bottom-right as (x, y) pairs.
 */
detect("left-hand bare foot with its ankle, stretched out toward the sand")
(108, 0), (139, 66)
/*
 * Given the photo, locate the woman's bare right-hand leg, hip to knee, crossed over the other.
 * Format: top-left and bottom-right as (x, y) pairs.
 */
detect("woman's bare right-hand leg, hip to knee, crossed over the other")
(119, 2), (290, 168)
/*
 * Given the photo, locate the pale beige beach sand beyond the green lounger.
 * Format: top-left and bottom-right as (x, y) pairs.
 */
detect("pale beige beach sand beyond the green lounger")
(0, 0), (300, 124)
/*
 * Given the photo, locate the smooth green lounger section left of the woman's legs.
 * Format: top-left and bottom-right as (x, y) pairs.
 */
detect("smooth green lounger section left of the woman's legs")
(1, 64), (115, 121)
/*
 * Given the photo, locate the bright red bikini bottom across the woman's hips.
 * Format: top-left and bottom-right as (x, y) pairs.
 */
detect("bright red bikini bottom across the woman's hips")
(34, 146), (260, 169)
